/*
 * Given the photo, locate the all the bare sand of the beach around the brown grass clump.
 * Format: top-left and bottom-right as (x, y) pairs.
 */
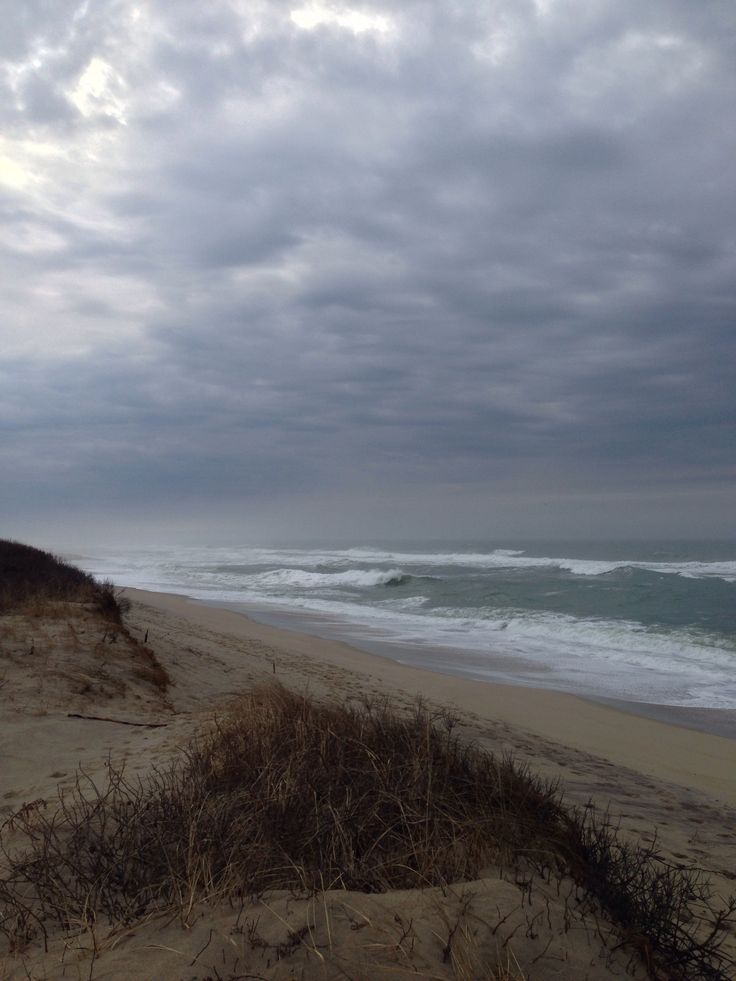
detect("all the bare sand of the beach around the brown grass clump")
(0, 589), (736, 978)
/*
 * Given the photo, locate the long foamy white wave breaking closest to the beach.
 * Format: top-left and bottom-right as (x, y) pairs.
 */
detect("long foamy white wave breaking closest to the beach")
(178, 590), (736, 709)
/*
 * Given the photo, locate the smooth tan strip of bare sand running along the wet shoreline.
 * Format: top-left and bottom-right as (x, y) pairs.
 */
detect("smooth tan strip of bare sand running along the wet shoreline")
(125, 588), (736, 807)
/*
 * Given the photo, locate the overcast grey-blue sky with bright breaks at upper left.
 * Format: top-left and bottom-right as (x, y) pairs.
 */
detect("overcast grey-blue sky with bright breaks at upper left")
(0, 0), (736, 546)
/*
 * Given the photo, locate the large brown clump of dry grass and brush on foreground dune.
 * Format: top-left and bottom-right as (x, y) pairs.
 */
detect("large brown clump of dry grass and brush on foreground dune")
(0, 685), (736, 981)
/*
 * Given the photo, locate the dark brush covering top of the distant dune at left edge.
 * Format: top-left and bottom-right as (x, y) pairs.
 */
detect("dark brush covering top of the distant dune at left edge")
(0, 540), (124, 623)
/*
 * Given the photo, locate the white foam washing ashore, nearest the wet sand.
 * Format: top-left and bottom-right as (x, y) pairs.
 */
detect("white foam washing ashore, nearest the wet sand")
(276, 601), (736, 708)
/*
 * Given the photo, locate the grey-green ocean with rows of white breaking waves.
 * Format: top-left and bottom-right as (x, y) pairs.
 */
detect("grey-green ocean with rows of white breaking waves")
(75, 542), (736, 724)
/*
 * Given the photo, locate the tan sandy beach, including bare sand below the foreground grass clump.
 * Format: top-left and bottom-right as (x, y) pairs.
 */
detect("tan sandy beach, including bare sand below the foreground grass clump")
(0, 590), (736, 979)
